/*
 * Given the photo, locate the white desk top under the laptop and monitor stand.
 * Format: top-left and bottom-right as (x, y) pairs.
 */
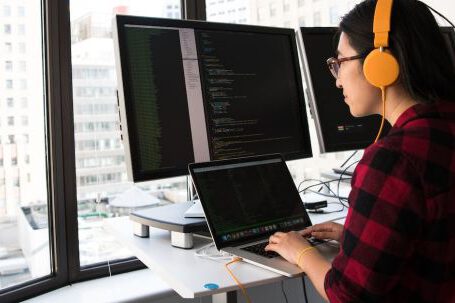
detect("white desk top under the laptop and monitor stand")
(104, 205), (347, 302)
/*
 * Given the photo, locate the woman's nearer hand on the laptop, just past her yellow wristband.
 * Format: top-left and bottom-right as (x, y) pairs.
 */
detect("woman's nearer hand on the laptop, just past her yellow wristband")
(265, 231), (311, 265)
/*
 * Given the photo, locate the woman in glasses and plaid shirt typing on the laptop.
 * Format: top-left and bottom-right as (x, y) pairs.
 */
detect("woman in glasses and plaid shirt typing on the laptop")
(266, 0), (455, 302)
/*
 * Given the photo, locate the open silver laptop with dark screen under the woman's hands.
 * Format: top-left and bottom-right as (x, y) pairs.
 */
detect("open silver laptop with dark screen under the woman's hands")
(188, 154), (320, 277)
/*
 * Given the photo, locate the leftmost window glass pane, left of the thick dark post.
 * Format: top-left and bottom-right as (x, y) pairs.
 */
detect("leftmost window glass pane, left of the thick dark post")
(0, 0), (51, 290)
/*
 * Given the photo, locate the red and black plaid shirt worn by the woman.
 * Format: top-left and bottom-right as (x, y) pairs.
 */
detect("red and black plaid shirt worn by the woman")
(325, 102), (455, 303)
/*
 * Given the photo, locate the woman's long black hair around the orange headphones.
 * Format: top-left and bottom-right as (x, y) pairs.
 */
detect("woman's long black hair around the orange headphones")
(340, 0), (455, 104)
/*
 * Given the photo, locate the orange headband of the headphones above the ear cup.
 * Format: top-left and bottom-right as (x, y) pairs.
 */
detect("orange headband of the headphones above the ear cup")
(373, 0), (393, 48)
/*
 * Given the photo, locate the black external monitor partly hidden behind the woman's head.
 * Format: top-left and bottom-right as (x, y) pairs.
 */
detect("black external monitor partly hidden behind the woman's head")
(299, 27), (455, 153)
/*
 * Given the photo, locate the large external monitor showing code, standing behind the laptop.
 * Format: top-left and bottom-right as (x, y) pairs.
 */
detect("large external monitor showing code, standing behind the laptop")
(114, 16), (312, 181)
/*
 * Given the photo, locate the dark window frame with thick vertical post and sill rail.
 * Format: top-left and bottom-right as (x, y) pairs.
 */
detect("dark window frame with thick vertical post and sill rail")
(0, 0), (206, 302)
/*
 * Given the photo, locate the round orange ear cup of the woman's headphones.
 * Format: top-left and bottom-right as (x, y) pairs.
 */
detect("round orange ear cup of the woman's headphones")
(363, 49), (400, 88)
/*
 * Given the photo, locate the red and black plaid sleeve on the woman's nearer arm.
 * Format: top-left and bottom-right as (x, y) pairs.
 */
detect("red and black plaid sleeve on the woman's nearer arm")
(325, 144), (425, 302)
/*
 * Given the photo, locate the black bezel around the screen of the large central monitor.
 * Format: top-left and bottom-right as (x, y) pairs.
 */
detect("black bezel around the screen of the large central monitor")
(115, 15), (313, 182)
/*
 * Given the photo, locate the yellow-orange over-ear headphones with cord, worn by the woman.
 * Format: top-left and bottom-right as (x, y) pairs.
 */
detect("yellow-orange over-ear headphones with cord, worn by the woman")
(363, 0), (400, 142)
